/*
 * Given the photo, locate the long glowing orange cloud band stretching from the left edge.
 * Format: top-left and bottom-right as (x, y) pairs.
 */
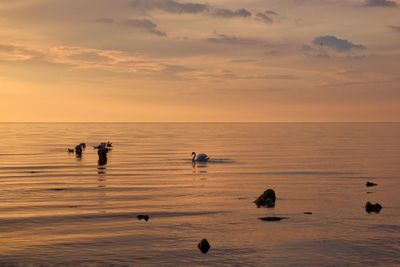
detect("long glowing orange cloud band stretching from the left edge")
(0, 43), (180, 76)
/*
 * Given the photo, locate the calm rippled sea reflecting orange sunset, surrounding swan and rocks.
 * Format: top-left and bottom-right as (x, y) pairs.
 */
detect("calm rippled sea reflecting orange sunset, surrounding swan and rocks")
(0, 124), (400, 266)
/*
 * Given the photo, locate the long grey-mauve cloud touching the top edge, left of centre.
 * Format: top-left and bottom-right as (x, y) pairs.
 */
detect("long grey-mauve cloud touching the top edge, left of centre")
(131, 0), (208, 14)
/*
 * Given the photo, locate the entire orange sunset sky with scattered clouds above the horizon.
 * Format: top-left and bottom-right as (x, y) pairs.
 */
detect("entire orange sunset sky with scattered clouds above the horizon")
(0, 0), (400, 122)
